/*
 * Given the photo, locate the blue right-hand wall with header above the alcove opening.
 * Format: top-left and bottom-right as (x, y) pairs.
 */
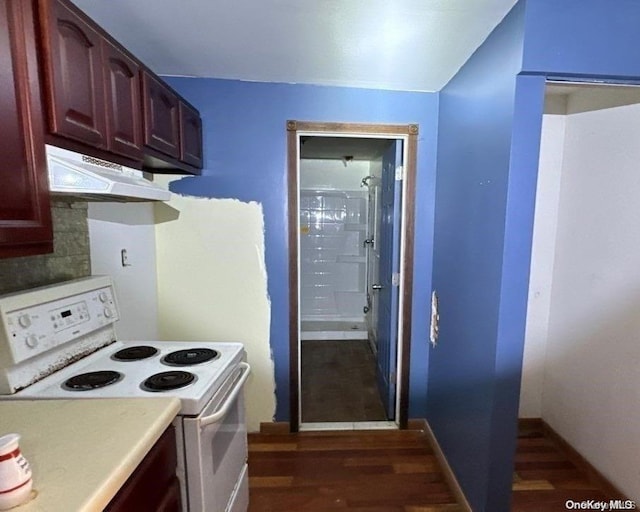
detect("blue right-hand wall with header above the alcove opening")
(428, 0), (640, 512)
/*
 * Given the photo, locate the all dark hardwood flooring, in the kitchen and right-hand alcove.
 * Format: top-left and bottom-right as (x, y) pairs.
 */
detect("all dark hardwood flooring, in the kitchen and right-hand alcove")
(249, 422), (620, 512)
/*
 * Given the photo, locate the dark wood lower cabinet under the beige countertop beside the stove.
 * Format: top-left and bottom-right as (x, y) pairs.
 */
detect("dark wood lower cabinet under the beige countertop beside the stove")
(104, 427), (182, 512)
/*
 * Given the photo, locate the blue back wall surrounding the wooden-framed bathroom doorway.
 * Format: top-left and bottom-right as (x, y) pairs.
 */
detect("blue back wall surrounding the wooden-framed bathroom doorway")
(166, 77), (438, 421)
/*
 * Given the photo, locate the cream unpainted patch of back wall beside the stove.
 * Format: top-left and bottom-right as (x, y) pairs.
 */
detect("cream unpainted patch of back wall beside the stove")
(156, 185), (275, 431)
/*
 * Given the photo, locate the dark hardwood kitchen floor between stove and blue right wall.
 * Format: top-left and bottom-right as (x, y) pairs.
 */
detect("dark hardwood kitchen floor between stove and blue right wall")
(249, 430), (462, 512)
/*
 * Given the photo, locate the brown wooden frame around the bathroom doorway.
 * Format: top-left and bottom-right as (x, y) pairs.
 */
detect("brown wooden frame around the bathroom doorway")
(286, 120), (418, 432)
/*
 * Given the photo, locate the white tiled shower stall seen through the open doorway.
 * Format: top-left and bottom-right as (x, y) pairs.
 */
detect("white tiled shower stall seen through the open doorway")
(299, 156), (377, 340)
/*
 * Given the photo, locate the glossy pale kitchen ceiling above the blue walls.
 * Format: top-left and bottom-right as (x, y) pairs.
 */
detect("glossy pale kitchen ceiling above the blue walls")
(73, 0), (516, 91)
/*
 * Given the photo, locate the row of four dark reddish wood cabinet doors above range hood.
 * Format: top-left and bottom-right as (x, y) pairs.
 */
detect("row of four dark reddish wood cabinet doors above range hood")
(37, 0), (202, 174)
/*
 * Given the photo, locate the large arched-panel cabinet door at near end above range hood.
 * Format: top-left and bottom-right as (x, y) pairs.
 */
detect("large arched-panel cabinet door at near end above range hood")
(40, 1), (106, 147)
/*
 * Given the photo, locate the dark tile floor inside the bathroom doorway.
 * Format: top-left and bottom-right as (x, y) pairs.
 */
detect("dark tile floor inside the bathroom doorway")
(301, 340), (388, 423)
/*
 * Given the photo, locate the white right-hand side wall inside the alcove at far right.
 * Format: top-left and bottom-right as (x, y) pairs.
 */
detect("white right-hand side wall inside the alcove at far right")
(523, 104), (640, 500)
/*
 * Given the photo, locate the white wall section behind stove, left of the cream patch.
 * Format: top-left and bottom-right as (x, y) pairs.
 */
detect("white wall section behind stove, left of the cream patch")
(88, 203), (158, 340)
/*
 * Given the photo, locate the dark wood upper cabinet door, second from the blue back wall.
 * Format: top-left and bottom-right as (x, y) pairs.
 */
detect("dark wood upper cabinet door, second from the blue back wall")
(142, 71), (180, 159)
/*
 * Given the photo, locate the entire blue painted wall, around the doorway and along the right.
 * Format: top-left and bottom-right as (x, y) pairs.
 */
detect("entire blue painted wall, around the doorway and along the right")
(161, 0), (640, 506)
